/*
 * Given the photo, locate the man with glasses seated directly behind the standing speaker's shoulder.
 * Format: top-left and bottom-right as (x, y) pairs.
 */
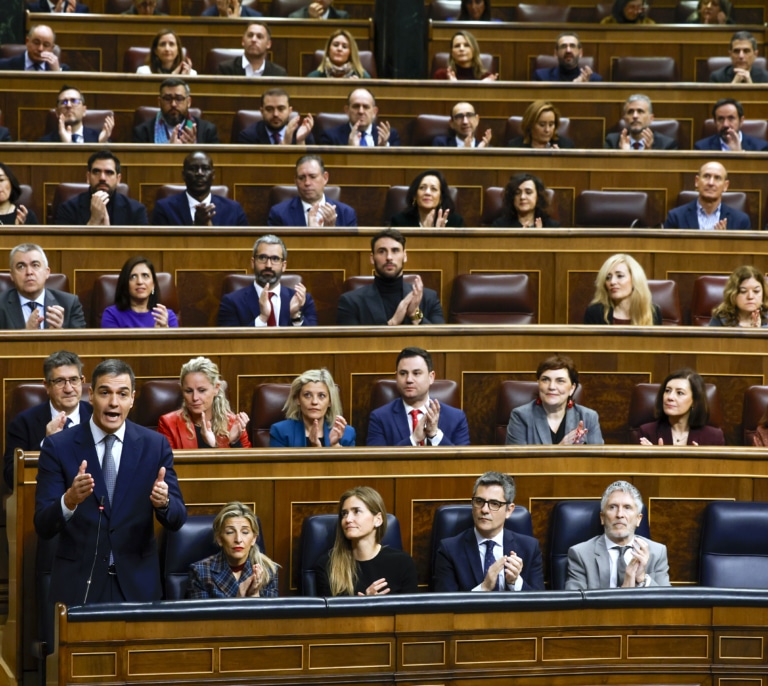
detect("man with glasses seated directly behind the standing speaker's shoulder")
(3, 350), (93, 490)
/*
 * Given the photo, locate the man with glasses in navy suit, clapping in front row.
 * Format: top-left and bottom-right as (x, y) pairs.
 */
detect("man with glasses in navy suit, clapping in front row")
(434, 472), (544, 592)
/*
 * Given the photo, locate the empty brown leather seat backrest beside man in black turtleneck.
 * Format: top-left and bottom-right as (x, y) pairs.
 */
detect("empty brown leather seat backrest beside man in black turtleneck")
(448, 274), (539, 324)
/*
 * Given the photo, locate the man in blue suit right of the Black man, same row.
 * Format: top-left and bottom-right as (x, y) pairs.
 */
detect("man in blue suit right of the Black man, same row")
(267, 155), (357, 227)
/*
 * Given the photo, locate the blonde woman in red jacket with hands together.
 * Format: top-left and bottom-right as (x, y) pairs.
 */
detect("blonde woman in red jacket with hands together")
(157, 357), (251, 450)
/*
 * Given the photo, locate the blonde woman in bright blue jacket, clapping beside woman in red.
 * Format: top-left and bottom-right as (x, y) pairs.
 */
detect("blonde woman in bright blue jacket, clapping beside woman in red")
(269, 368), (355, 448)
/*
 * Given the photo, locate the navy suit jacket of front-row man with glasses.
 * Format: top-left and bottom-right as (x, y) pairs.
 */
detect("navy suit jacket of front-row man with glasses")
(434, 528), (544, 593)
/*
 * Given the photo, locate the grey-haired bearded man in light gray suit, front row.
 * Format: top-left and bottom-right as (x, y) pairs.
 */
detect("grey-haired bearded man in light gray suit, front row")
(565, 481), (670, 591)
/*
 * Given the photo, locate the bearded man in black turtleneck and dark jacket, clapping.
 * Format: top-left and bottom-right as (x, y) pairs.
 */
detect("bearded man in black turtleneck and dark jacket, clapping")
(336, 229), (445, 326)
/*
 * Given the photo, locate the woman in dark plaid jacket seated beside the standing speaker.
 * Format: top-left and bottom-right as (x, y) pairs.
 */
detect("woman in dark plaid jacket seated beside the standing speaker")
(186, 501), (278, 600)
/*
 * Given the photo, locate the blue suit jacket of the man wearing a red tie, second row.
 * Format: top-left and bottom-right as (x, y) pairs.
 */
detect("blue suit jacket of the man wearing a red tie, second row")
(366, 398), (469, 446)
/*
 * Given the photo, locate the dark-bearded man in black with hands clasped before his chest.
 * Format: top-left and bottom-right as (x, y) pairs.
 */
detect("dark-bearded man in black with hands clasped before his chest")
(56, 150), (148, 226)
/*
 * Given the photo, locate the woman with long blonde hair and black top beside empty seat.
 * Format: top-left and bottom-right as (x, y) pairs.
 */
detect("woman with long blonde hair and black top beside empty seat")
(584, 253), (661, 326)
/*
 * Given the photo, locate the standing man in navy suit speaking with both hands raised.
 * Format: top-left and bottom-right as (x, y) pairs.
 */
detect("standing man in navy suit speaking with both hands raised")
(34, 359), (187, 605)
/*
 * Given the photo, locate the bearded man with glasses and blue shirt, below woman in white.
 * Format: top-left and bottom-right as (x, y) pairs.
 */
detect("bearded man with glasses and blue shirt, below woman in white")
(133, 76), (219, 144)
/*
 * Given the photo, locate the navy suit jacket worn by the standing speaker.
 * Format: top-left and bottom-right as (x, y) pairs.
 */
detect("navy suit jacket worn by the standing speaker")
(35, 422), (187, 605)
